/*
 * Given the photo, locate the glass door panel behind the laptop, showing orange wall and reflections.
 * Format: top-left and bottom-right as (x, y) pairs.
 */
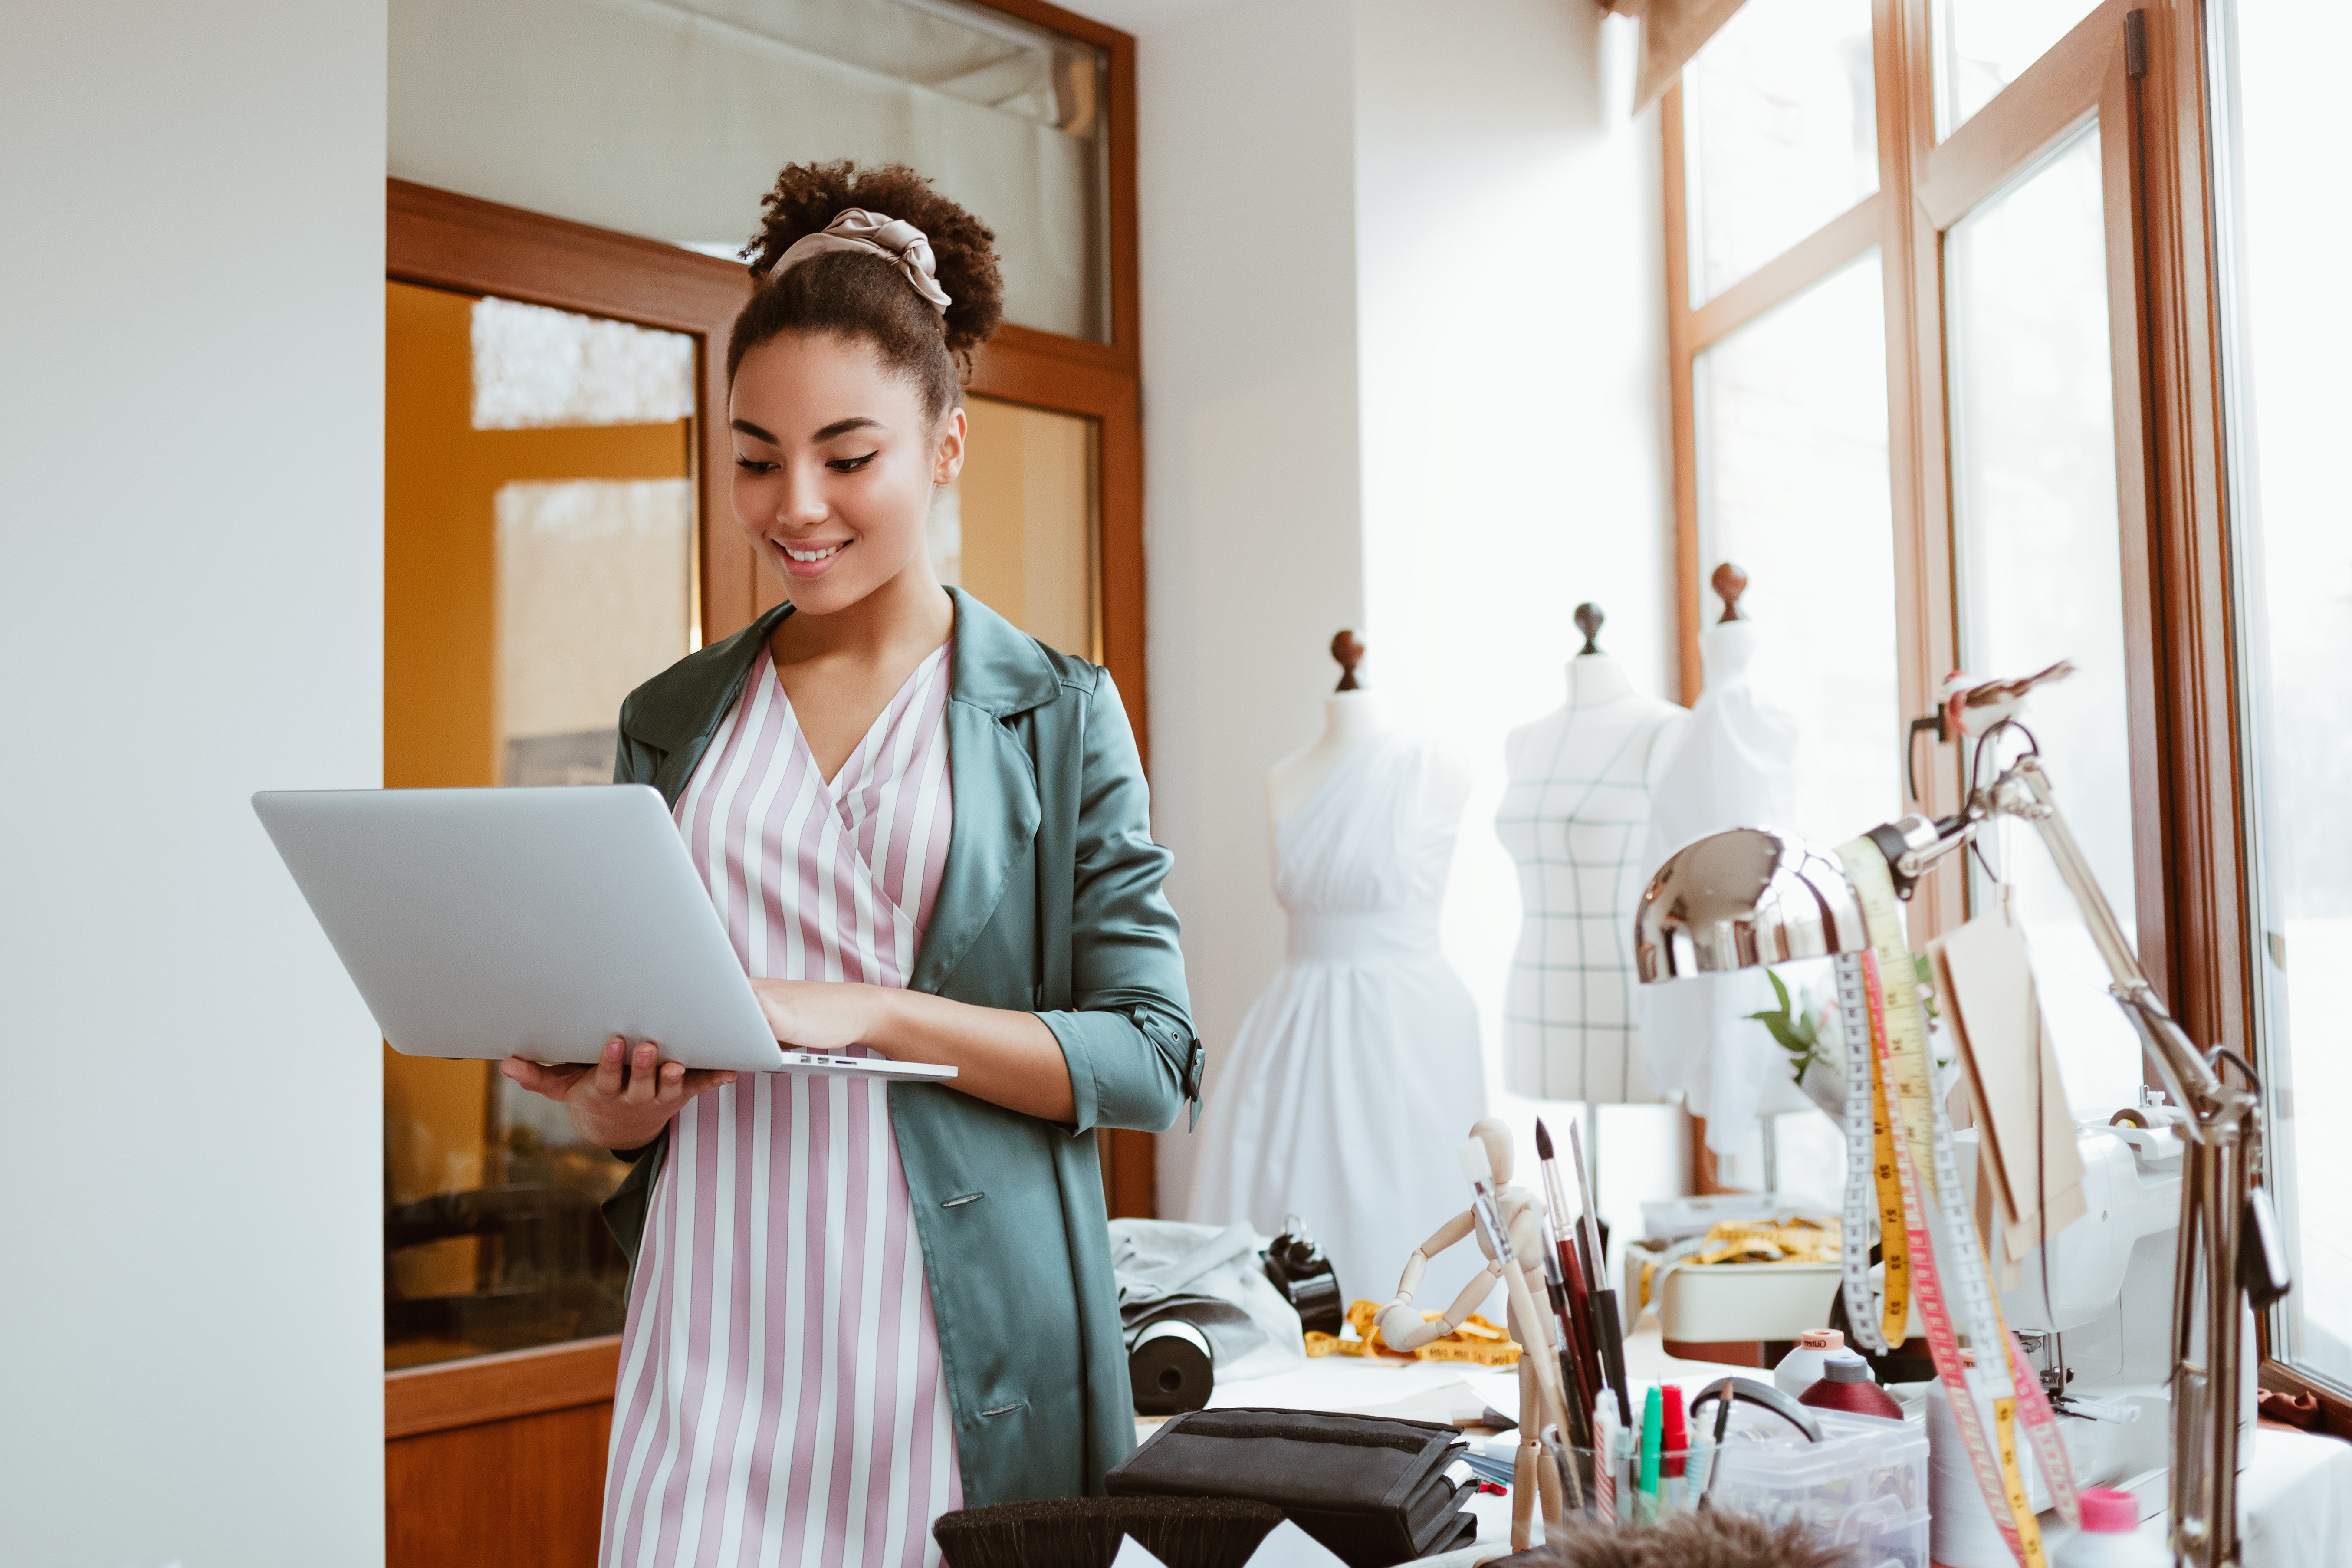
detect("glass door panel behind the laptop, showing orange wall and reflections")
(383, 282), (696, 1366)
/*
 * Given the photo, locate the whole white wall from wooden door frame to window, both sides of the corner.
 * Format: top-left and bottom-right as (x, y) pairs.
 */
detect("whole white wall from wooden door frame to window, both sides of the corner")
(1082, 0), (1684, 1220)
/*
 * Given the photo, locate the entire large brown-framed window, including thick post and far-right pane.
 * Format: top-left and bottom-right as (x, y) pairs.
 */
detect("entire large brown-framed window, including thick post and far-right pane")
(1663, 0), (2352, 1434)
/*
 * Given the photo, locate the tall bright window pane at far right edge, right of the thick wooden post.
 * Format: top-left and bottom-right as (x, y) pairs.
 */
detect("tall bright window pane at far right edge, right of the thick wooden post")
(2211, 5), (2352, 1389)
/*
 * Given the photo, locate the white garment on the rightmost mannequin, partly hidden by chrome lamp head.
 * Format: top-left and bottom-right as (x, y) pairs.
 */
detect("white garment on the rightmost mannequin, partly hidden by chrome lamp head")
(1642, 621), (1807, 1154)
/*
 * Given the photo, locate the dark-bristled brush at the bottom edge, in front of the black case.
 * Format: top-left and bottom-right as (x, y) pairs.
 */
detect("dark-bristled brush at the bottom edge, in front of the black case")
(931, 1497), (1282, 1568)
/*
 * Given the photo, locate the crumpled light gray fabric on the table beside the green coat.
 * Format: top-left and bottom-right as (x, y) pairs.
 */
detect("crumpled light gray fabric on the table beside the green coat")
(1110, 1220), (1308, 1382)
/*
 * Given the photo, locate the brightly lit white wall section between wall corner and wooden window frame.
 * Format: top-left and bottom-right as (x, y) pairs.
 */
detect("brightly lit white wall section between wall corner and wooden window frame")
(1355, 0), (1689, 1227)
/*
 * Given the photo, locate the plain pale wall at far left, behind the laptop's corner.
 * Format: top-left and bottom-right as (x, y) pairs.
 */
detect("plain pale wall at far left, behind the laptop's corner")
(0, 0), (383, 1568)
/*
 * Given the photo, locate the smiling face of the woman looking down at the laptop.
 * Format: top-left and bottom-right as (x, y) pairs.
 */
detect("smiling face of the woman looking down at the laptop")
(729, 334), (964, 616)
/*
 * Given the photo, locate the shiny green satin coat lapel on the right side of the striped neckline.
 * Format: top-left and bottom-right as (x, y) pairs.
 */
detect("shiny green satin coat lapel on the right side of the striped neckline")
(908, 588), (1056, 992)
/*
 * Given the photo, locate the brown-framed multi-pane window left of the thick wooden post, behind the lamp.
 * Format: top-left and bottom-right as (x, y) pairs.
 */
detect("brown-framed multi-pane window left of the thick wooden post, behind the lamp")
(1663, 0), (2227, 1192)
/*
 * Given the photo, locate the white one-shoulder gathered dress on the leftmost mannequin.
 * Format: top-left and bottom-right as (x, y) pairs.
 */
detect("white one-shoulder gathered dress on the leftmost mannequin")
(1190, 691), (1486, 1300)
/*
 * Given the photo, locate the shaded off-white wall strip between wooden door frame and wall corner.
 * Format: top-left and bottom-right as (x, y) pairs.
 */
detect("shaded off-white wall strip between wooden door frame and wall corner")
(1113, 0), (1364, 1215)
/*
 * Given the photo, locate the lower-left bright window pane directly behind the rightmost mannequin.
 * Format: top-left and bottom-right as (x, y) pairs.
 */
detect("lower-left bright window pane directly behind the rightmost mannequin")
(1693, 249), (1903, 844)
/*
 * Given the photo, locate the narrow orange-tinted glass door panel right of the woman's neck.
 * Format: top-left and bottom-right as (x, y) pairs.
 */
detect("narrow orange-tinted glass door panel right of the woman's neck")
(931, 397), (1103, 663)
